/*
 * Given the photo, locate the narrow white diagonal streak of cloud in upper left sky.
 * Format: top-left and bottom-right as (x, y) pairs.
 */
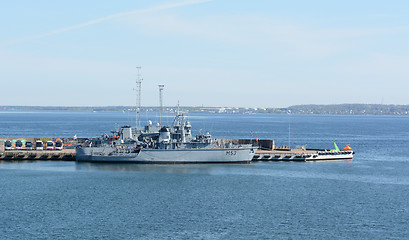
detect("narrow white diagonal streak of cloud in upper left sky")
(0, 0), (213, 45)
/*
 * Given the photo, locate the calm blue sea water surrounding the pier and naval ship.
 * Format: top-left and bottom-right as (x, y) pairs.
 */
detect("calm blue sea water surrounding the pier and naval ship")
(0, 112), (409, 239)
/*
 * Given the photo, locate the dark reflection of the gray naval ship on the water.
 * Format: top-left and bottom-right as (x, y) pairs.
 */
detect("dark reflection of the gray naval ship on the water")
(75, 162), (242, 174)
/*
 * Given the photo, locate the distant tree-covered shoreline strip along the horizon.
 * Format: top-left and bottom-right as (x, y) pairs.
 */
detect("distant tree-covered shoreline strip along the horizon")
(0, 104), (409, 115)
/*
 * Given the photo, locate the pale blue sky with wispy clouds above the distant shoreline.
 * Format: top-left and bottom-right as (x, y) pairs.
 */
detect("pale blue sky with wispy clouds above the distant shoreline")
(0, 0), (409, 108)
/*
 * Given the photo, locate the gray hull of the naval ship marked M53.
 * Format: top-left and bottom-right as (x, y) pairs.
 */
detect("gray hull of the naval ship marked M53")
(76, 147), (255, 164)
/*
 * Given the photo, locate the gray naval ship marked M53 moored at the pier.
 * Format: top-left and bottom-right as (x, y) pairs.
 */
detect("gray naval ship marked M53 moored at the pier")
(76, 111), (256, 164)
